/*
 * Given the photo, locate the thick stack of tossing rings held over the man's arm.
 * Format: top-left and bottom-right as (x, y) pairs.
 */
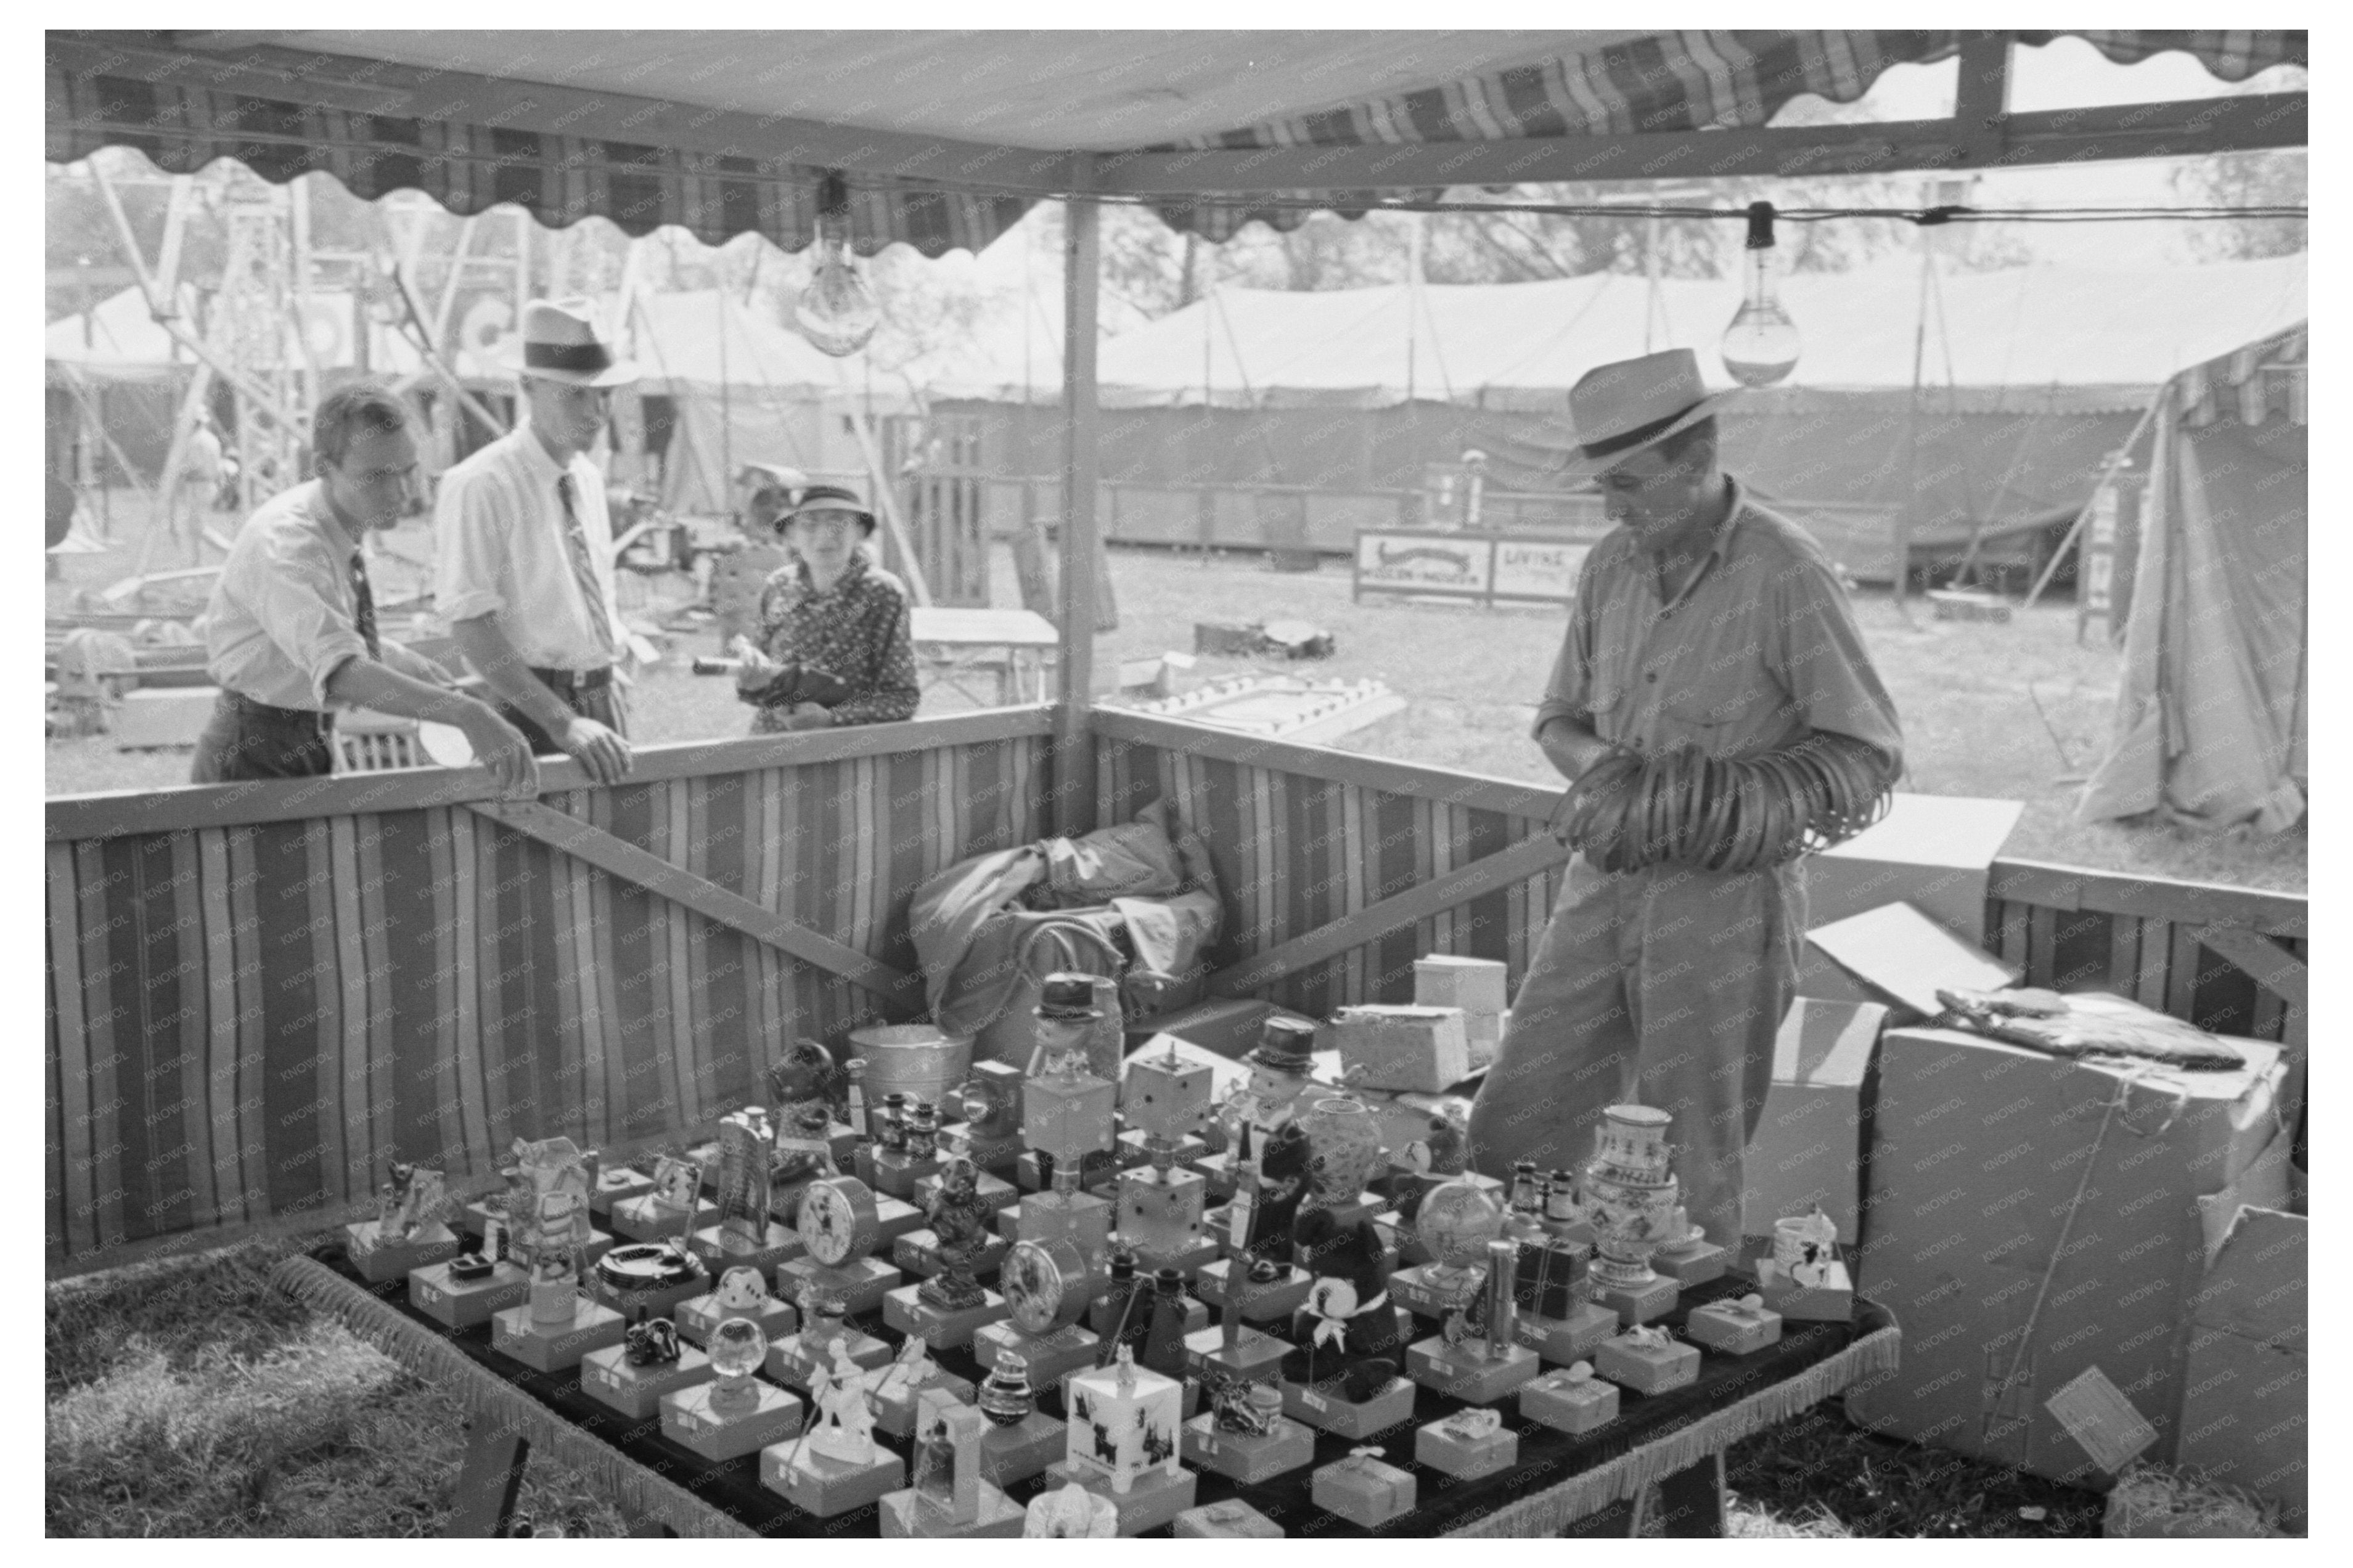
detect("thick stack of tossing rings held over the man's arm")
(1553, 735), (1894, 871)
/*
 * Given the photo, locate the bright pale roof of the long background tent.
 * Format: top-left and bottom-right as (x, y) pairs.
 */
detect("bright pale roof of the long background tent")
(1078, 255), (2306, 412)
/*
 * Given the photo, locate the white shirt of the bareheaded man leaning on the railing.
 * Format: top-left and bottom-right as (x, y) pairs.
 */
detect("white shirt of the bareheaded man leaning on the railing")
(202, 480), (367, 713)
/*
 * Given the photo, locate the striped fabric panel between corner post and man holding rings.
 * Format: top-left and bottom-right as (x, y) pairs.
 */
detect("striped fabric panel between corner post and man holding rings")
(1097, 737), (1562, 1017)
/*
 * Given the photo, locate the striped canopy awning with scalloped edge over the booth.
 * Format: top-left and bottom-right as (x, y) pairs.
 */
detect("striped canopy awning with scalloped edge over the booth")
(47, 31), (2306, 255)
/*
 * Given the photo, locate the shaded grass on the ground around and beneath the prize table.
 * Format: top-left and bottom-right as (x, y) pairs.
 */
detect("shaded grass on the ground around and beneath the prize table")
(45, 1241), (2101, 1537)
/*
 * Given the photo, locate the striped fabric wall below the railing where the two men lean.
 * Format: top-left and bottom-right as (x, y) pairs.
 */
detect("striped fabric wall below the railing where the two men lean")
(45, 735), (1047, 1267)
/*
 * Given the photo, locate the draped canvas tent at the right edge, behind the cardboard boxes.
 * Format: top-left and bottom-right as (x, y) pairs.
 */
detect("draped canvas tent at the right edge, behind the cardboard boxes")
(2077, 322), (2310, 833)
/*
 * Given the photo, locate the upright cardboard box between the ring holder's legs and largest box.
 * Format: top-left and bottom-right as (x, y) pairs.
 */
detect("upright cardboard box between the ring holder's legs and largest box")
(1741, 996), (1887, 1243)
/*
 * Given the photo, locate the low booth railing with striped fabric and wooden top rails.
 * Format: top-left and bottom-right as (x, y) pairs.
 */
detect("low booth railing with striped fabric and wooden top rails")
(45, 709), (2308, 1272)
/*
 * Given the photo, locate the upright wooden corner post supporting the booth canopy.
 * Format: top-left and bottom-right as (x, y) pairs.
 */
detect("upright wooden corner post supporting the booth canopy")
(1052, 153), (1101, 833)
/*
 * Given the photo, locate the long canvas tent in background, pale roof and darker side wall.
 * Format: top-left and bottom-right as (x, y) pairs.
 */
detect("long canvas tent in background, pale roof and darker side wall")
(956, 255), (2306, 574)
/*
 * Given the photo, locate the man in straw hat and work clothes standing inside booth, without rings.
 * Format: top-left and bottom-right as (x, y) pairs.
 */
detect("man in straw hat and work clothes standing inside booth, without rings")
(1471, 348), (1904, 1248)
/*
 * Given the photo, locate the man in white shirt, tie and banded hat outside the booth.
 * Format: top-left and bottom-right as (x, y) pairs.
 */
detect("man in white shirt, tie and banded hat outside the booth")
(433, 299), (637, 784)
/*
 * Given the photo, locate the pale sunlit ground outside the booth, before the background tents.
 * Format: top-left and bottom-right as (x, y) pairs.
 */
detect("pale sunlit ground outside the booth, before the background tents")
(47, 492), (2306, 892)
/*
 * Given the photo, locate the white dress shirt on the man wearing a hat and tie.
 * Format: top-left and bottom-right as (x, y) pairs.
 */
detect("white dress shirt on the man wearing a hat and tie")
(433, 426), (624, 671)
